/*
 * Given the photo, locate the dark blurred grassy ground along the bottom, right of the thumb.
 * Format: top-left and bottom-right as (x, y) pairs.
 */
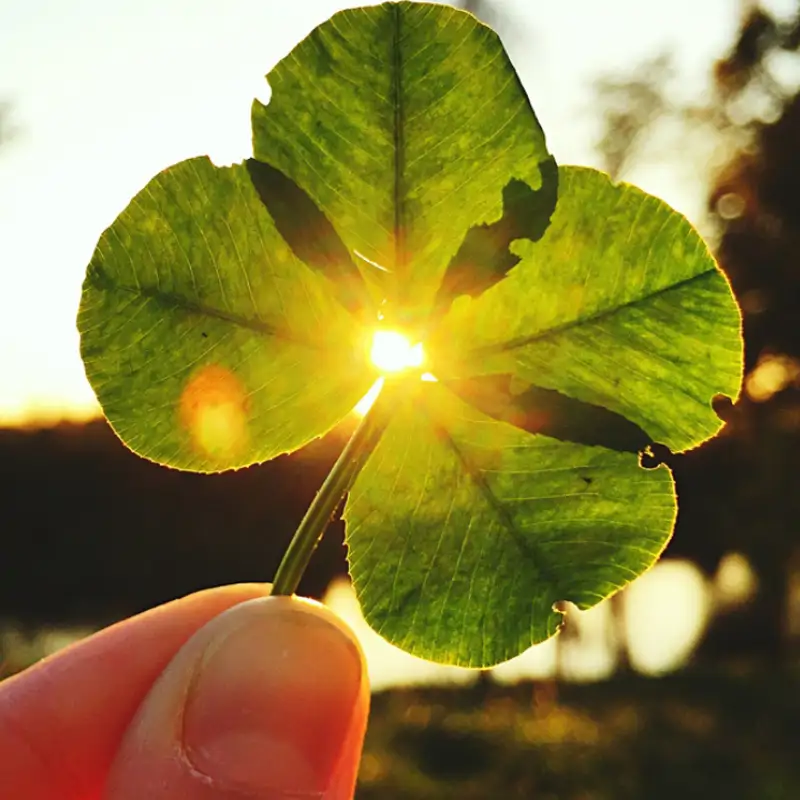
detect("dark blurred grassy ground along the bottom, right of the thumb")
(356, 669), (800, 800)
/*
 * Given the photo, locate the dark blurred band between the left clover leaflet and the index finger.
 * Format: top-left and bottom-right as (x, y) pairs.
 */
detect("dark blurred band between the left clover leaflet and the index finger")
(0, 421), (345, 627)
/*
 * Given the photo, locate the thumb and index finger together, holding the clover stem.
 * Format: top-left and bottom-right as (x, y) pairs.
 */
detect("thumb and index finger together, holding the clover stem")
(0, 585), (369, 800)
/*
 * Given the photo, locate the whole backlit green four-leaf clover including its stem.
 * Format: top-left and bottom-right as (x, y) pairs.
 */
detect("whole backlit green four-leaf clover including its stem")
(78, 2), (742, 666)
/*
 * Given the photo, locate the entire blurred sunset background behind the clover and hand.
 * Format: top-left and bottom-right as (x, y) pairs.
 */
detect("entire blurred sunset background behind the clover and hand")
(0, 0), (800, 800)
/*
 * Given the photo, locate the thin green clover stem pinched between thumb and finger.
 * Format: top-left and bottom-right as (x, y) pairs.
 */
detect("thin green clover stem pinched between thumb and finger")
(272, 379), (396, 595)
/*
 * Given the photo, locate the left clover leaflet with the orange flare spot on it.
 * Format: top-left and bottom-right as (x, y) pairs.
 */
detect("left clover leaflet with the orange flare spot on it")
(78, 158), (375, 471)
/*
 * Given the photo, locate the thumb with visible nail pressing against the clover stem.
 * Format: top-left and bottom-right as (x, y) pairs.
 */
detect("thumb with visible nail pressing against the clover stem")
(105, 597), (369, 800)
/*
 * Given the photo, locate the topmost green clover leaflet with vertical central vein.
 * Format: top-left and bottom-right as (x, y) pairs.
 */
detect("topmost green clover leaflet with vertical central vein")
(253, 2), (552, 326)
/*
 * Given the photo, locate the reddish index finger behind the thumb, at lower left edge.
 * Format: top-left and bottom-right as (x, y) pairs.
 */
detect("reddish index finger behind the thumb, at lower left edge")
(0, 584), (269, 800)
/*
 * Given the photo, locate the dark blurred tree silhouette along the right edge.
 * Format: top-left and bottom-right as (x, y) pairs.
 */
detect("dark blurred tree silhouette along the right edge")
(597, 4), (800, 657)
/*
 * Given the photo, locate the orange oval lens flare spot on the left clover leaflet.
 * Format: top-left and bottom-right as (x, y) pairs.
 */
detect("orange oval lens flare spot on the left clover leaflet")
(180, 364), (248, 460)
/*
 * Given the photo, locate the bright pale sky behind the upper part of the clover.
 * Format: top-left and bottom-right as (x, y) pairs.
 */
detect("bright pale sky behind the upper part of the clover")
(0, 0), (768, 424)
